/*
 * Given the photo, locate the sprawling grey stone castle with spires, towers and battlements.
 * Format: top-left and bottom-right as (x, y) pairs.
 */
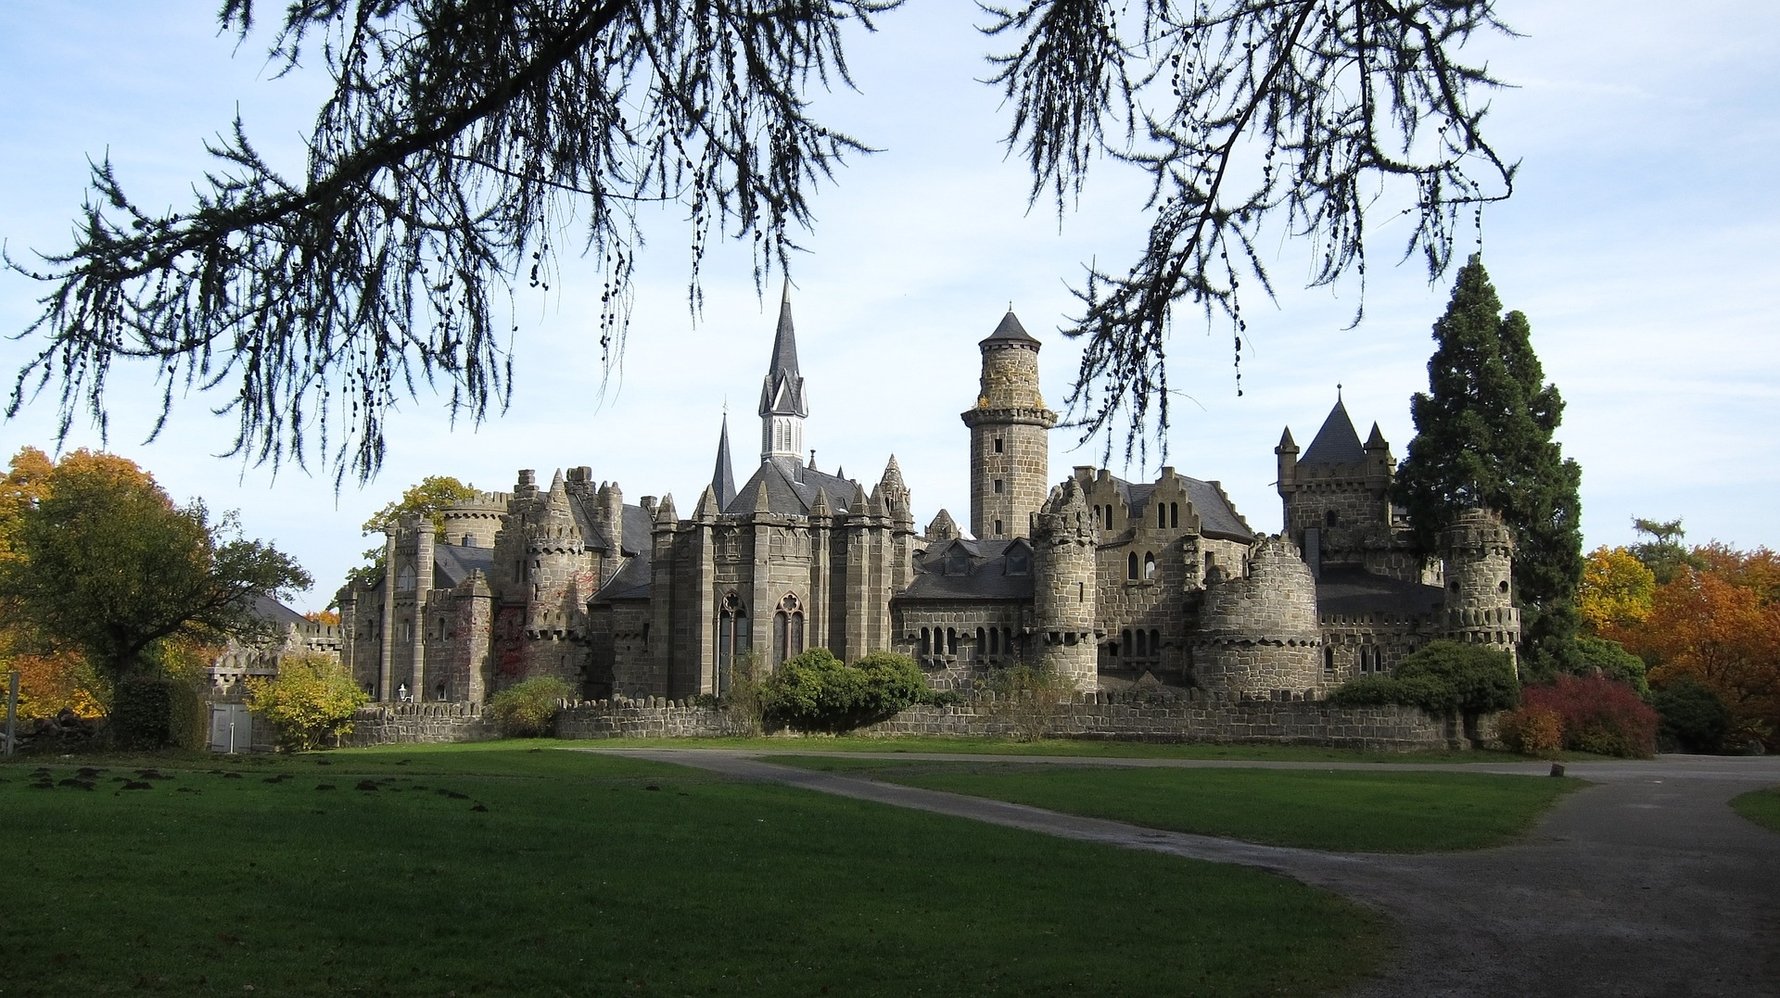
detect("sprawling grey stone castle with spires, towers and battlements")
(338, 290), (1520, 703)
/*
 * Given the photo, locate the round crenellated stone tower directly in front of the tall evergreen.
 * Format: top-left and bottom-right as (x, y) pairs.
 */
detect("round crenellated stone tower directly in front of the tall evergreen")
(1440, 509), (1520, 655)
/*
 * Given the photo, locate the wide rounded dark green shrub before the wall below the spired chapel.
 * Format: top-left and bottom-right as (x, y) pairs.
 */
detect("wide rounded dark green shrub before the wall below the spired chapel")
(760, 648), (927, 731)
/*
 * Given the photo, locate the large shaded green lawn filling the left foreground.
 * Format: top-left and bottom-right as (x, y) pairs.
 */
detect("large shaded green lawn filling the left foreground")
(0, 742), (1388, 996)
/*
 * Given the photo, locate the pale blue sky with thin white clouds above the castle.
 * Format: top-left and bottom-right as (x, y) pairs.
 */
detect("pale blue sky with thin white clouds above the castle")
(0, 0), (1780, 610)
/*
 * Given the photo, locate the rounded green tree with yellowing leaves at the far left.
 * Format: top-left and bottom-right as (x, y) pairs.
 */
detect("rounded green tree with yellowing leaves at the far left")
(0, 452), (310, 681)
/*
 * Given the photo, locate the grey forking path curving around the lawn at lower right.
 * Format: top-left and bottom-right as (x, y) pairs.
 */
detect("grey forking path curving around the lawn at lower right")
(594, 749), (1780, 998)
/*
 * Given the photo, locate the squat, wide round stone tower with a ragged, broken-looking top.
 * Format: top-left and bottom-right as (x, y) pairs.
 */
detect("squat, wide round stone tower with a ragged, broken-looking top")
(1193, 537), (1323, 699)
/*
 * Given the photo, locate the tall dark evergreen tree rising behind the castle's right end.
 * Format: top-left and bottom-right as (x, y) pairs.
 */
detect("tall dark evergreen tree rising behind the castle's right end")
(1396, 256), (1582, 674)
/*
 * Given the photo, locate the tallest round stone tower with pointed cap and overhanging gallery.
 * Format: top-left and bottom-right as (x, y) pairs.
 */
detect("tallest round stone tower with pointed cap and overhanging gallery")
(961, 310), (1053, 537)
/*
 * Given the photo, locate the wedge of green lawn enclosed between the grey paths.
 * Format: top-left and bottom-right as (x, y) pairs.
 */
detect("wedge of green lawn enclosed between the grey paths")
(773, 756), (1581, 852)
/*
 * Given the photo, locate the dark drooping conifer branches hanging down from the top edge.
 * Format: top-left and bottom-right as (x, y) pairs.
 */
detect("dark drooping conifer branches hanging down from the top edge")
(7, 0), (1513, 482)
